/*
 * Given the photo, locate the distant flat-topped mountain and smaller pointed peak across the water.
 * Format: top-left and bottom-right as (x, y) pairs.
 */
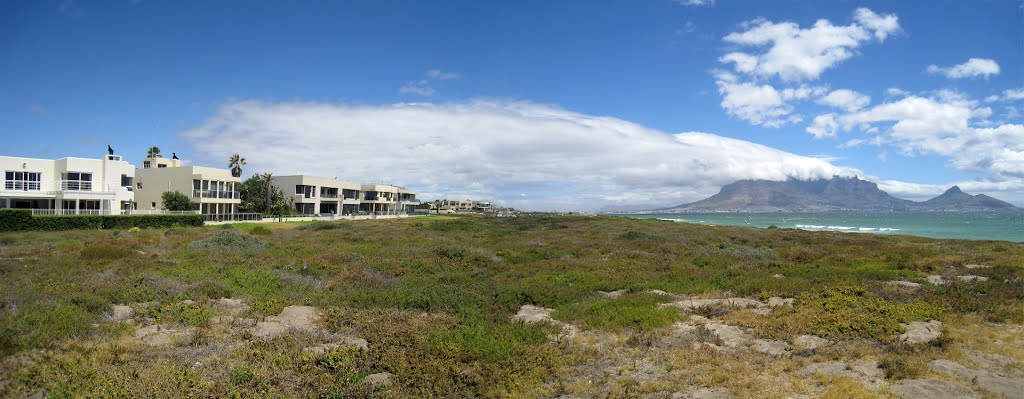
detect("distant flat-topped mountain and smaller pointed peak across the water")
(657, 176), (1020, 212)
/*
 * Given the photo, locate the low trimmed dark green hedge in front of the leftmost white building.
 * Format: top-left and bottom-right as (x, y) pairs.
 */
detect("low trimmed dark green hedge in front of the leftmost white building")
(0, 209), (206, 231)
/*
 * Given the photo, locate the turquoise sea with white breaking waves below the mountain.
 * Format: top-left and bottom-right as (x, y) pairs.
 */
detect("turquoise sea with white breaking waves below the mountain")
(616, 212), (1024, 241)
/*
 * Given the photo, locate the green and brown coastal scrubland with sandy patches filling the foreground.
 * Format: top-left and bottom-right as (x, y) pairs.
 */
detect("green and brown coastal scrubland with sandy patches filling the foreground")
(0, 216), (1024, 398)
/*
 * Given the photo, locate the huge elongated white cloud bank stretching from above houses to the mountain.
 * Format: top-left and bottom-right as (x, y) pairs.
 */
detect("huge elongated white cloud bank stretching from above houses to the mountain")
(182, 100), (857, 210)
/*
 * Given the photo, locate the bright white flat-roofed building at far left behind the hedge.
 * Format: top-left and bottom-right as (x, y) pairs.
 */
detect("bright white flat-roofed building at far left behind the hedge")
(0, 154), (135, 215)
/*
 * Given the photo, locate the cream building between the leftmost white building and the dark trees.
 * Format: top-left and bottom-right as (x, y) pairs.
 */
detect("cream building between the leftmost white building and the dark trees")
(134, 156), (242, 215)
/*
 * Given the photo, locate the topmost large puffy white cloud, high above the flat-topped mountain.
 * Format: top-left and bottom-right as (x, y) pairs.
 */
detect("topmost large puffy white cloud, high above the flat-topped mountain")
(720, 8), (899, 81)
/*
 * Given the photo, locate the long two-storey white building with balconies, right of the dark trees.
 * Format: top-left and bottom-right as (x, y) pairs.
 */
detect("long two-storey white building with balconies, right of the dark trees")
(271, 175), (420, 215)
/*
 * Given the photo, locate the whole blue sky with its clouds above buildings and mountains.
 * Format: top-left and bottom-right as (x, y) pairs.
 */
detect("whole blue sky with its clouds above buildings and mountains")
(0, 0), (1024, 210)
